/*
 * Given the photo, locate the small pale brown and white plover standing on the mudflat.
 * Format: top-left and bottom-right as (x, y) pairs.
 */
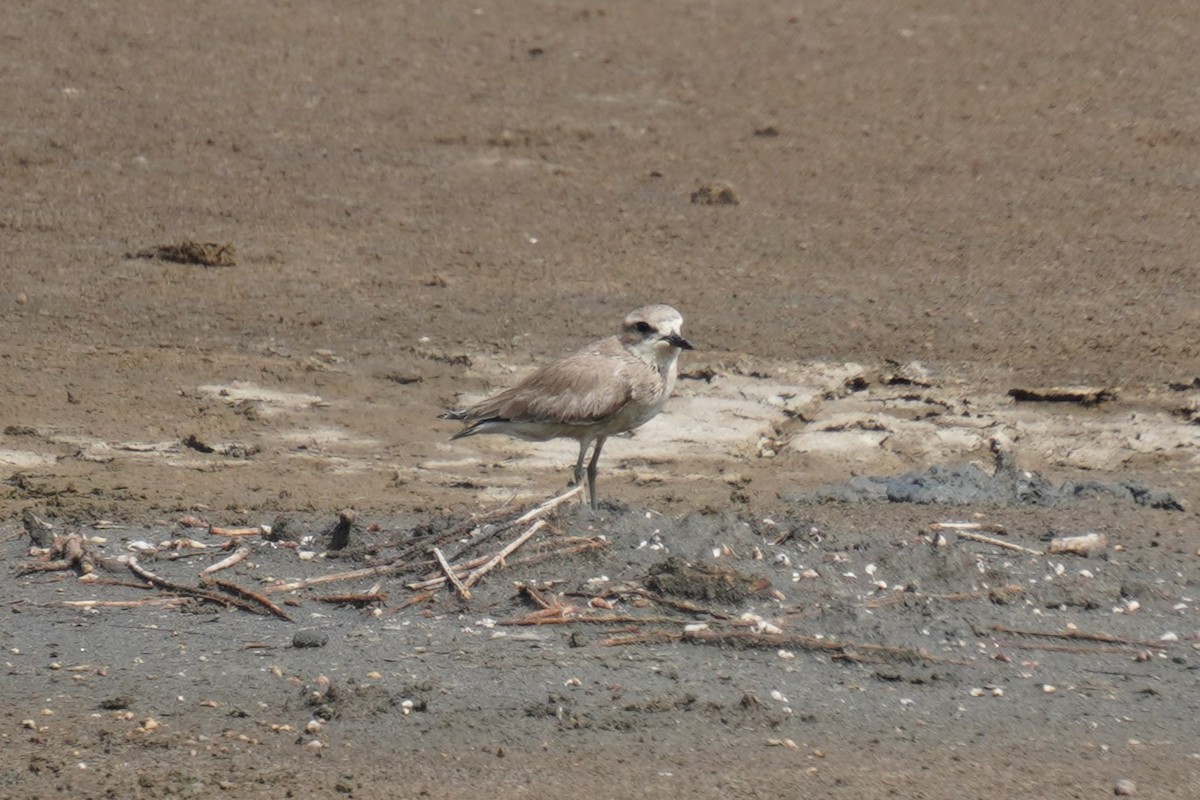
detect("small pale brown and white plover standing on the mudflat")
(442, 305), (692, 509)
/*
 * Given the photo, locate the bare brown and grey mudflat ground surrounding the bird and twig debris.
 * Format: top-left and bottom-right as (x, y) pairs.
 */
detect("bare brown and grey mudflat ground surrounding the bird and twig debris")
(0, 0), (1200, 800)
